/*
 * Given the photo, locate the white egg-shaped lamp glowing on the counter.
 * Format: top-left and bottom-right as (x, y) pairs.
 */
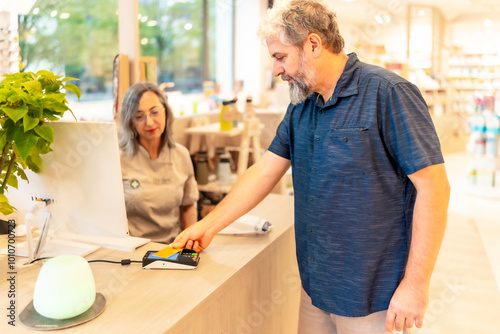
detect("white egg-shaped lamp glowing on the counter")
(33, 255), (96, 319)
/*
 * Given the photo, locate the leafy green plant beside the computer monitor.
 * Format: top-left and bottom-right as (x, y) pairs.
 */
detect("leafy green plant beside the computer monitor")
(0, 70), (81, 215)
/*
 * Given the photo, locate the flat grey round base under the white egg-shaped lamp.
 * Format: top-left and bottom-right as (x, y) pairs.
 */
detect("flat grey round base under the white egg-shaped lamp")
(19, 292), (106, 331)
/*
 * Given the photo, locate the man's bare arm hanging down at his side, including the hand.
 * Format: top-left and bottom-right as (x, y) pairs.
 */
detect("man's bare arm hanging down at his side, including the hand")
(386, 164), (450, 333)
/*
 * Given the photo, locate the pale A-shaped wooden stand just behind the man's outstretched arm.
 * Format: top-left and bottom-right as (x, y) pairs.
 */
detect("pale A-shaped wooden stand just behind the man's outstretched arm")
(237, 117), (260, 176)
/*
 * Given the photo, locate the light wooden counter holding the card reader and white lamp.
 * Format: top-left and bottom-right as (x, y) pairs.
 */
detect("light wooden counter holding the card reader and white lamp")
(0, 194), (300, 334)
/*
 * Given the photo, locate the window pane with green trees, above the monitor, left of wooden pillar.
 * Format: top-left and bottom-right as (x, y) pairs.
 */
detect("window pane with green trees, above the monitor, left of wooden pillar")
(18, 0), (118, 102)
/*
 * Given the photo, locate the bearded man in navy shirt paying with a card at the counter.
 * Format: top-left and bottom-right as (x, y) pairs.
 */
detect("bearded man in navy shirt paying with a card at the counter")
(173, 0), (450, 334)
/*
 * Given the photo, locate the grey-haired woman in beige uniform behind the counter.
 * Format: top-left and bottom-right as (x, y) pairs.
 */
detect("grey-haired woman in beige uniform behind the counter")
(119, 82), (199, 243)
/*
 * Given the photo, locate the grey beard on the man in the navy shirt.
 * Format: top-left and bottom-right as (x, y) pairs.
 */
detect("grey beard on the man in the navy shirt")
(281, 52), (316, 105)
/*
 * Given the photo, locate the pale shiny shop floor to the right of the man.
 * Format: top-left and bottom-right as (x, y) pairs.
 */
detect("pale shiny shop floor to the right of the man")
(412, 153), (500, 334)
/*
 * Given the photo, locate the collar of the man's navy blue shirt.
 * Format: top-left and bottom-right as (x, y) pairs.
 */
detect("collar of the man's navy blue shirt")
(309, 52), (361, 108)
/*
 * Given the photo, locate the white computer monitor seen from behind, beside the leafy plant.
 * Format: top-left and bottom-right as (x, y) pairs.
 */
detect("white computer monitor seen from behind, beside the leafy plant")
(7, 121), (149, 255)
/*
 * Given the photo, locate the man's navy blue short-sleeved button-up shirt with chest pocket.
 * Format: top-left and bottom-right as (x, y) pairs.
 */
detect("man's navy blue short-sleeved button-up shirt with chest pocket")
(269, 53), (443, 317)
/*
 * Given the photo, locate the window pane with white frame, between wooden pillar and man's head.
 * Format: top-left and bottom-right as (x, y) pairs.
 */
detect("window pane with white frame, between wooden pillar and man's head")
(139, 0), (234, 93)
